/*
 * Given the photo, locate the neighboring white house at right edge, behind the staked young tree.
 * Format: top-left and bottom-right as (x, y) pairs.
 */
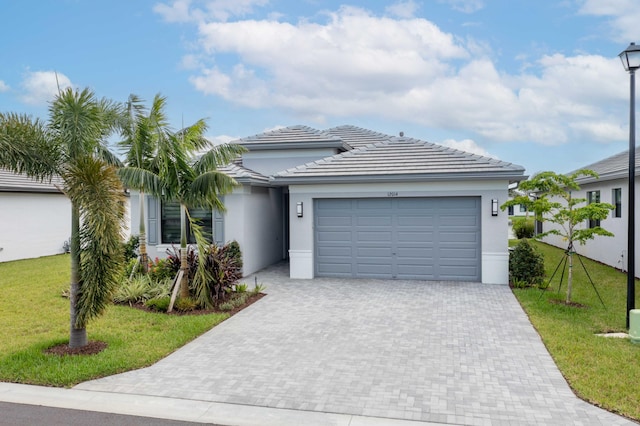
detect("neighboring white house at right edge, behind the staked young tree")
(543, 151), (640, 276)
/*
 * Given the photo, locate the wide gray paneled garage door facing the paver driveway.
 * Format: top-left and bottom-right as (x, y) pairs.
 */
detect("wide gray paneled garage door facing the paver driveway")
(314, 197), (480, 281)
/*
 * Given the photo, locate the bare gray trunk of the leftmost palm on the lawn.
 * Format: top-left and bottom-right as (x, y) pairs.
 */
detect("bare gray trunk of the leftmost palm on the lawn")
(69, 204), (87, 348)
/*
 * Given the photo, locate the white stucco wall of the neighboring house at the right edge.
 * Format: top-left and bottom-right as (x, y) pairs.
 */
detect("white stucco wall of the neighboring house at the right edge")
(542, 178), (640, 276)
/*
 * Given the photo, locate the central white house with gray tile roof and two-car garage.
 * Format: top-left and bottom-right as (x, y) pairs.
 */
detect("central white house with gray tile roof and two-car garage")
(131, 126), (526, 284)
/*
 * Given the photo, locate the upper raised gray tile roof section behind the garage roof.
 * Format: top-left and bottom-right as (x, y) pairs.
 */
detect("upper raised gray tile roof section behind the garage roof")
(233, 126), (351, 151)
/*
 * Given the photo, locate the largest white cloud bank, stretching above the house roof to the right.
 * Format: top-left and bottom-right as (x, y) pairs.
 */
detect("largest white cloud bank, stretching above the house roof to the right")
(165, 3), (628, 145)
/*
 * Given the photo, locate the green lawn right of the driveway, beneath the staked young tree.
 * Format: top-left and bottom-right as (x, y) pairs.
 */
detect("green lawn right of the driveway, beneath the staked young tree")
(514, 242), (640, 420)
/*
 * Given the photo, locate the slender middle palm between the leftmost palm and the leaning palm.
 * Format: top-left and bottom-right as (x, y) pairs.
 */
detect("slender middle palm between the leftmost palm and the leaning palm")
(118, 94), (169, 273)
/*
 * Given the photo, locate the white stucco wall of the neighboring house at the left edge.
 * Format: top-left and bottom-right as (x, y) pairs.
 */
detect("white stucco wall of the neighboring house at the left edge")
(0, 192), (71, 262)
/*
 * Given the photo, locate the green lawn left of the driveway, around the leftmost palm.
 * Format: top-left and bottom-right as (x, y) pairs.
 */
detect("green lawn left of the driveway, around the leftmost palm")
(0, 255), (228, 387)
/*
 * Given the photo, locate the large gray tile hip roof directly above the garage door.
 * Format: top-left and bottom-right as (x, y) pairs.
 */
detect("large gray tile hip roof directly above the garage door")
(273, 137), (525, 184)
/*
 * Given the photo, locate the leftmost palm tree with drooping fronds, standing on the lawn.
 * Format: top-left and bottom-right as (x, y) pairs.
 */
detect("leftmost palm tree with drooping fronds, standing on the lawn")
(0, 88), (124, 348)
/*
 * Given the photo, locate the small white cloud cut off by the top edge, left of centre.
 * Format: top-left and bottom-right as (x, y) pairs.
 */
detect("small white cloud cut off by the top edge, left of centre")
(153, 0), (269, 23)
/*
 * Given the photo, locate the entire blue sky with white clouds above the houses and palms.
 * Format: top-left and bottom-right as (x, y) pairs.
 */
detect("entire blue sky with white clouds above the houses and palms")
(0, 0), (640, 174)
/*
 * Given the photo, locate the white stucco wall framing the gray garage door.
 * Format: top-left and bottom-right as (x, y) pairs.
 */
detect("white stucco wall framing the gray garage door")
(289, 180), (509, 284)
